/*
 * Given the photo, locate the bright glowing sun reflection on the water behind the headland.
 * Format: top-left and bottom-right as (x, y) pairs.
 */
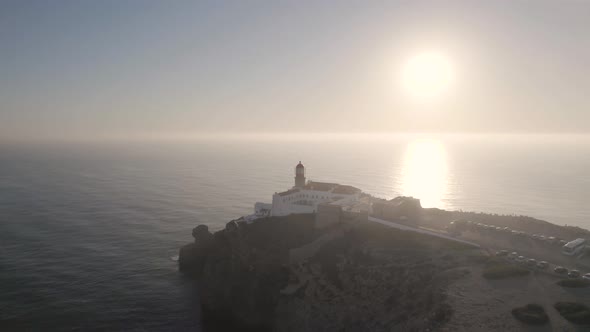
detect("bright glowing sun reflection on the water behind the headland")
(401, 139), (448, 208)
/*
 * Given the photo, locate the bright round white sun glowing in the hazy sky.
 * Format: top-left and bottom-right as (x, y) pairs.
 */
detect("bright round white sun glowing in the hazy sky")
(402, 52), (453, 99)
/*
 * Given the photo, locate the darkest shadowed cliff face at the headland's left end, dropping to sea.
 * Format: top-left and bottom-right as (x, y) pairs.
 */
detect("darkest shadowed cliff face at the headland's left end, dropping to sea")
(179, 215), (315, 331)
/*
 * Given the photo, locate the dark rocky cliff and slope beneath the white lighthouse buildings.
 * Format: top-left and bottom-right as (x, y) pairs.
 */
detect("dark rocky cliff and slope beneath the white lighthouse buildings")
(179, 215), (474, 331)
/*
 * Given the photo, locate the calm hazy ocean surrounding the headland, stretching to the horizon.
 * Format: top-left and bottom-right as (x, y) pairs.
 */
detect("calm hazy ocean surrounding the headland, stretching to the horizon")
(0, 135), (590, 331)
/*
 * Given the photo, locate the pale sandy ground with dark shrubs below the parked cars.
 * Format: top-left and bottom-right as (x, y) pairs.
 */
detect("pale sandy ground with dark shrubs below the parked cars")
(441, 266), (590, 332)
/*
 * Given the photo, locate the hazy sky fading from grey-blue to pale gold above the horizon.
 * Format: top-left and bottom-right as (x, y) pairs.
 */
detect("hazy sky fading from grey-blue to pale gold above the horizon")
(0, 0), (590, 139)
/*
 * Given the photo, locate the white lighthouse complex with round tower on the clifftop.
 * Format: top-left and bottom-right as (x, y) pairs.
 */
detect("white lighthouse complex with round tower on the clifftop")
(254, 162), (361, 216)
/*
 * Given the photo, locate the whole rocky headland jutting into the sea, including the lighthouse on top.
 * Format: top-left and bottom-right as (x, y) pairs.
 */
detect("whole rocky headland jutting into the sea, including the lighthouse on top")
(179, 163), (590, 331)
